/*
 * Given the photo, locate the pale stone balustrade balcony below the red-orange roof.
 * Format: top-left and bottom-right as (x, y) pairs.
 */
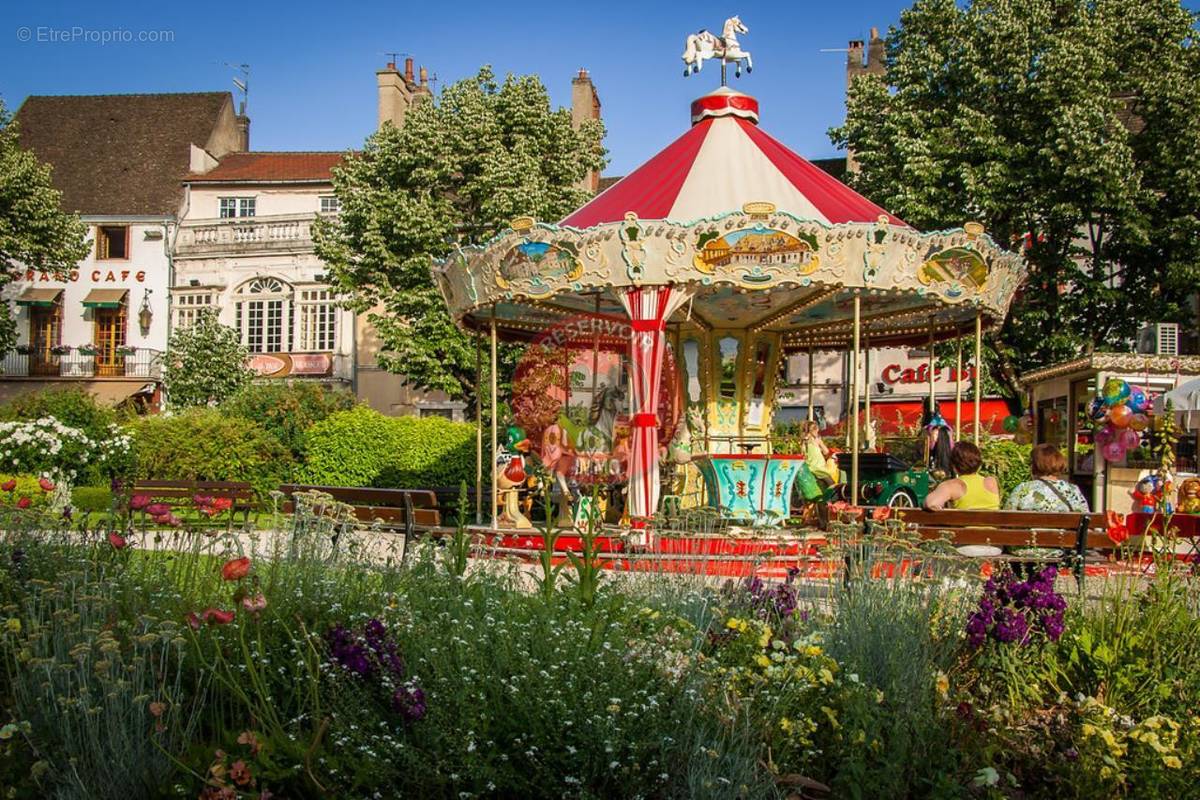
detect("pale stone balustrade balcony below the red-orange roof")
(175, 213), (317, 258)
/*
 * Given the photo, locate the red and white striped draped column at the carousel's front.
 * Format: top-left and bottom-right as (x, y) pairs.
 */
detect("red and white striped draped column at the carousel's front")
(620, 287), (690, 527)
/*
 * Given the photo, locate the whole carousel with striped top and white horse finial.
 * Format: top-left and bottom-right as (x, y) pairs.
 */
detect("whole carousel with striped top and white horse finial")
(433, 18), (1024, 546)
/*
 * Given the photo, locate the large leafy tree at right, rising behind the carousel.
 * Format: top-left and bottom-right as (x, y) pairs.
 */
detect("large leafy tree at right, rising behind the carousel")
(830, 0), (1200, 396)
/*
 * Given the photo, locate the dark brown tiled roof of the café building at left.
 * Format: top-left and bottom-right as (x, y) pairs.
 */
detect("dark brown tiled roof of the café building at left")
(16, 91), (233, 216)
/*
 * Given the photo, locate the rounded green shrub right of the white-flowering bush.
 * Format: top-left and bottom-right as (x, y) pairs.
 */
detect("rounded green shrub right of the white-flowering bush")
(130, 409), (292, 495)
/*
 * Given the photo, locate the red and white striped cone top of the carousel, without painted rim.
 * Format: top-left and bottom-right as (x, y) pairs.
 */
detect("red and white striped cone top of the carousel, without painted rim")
(560, 86), (905, 228)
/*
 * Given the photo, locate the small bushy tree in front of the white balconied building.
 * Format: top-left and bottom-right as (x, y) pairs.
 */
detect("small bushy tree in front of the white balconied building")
(162, 311), (254, 409)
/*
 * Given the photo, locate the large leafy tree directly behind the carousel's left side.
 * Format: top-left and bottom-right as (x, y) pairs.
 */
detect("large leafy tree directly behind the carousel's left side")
(314, 67), (604, 410)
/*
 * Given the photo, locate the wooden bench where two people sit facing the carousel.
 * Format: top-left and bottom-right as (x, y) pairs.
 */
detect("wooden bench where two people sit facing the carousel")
(888, 509), (1116, 587)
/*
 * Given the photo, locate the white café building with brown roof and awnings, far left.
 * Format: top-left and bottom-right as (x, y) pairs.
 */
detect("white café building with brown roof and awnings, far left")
(0, 92), (248, 408)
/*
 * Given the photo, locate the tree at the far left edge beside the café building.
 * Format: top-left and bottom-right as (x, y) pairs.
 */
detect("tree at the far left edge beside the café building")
(0, 95), (88, 353)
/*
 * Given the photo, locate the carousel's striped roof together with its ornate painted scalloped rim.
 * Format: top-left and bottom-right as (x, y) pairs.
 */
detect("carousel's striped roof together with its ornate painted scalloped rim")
(433, 88), (1024, 350)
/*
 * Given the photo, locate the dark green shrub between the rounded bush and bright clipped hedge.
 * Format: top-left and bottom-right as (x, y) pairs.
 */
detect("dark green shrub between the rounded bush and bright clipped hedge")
(221, 380), (358, 461)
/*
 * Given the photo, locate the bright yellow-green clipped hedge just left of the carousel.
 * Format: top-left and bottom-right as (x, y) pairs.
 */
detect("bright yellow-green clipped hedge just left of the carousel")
(299, 405), (475, 488)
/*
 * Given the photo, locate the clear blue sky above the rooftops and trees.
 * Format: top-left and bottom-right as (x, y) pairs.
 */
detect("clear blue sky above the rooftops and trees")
(0, 0), (1185, 174)
